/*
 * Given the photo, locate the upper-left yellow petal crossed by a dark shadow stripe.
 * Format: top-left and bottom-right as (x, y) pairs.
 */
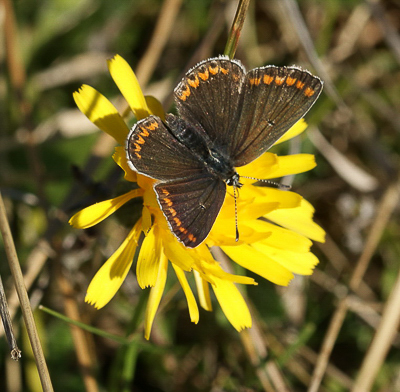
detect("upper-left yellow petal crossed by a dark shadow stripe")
(73, 84), (129, 145)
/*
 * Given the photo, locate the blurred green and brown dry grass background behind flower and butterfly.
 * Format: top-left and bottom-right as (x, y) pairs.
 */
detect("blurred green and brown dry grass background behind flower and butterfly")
(0, 0), (400, 392)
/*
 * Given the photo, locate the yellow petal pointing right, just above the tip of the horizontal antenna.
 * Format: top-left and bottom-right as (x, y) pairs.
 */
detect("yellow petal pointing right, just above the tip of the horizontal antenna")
(268, 154), (317, 180)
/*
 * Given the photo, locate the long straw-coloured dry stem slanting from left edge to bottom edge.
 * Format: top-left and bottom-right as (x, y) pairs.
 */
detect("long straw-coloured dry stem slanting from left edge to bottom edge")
(0, 192), (53, 392)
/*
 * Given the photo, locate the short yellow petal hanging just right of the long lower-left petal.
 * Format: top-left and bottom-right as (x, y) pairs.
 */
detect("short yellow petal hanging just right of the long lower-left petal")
(136, 226), (160, 289)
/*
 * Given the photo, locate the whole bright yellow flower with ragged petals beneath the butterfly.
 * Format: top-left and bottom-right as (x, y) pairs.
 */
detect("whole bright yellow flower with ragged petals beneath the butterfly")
(70, 55), (324, 339)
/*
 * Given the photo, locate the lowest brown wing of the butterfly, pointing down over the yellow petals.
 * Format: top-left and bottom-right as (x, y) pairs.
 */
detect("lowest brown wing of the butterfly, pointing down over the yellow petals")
(154, 174), (226, 248)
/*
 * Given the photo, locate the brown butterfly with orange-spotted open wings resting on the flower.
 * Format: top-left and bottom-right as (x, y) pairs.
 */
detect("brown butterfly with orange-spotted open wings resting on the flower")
(126, 56), (323, 248)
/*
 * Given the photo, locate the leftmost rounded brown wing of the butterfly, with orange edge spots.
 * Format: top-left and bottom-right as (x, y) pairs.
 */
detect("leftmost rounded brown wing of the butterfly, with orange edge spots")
(126, 116), (205, 181)
